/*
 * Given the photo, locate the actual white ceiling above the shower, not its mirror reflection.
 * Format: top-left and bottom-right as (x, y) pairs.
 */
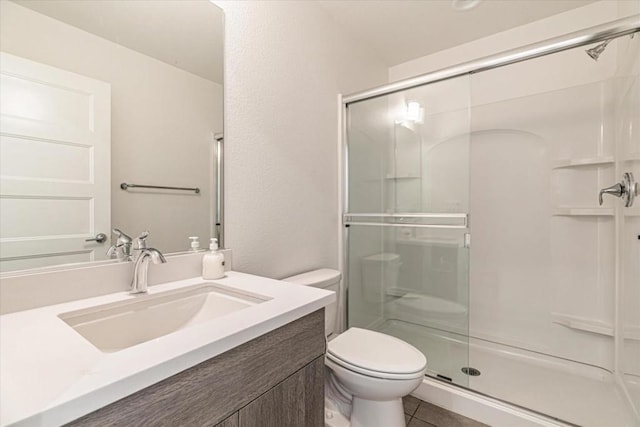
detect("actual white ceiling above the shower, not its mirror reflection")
(318, 0), (595, 66)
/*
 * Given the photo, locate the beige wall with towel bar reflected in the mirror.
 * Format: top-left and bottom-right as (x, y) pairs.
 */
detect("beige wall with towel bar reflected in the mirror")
(0, 1), (222, 253)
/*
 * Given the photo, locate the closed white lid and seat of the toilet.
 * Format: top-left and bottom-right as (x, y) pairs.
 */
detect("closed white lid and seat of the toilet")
(327, 328), (427, 374)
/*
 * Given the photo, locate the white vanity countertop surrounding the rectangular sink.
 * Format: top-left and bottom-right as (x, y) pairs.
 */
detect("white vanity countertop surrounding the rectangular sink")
(0, 272), (335, 426)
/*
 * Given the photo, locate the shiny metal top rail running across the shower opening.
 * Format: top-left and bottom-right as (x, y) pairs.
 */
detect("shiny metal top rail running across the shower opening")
(342, 14), (640, 105)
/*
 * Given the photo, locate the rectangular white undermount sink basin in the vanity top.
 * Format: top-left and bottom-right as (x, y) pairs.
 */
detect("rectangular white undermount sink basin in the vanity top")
(59, 283), (270, 353)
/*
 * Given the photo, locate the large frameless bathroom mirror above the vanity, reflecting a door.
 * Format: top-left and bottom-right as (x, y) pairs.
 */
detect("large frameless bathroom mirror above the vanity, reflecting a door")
(0, 0), (224, 273)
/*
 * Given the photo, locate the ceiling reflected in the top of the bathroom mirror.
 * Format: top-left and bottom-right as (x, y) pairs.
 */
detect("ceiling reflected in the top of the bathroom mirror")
(14, 0), (224, 84)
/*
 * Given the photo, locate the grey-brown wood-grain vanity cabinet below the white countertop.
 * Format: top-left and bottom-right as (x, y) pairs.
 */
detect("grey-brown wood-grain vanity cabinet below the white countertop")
(67, 309), (325, 427)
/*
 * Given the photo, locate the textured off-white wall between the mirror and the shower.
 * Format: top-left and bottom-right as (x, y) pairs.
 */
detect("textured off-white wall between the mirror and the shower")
(216, 1), (387, 278)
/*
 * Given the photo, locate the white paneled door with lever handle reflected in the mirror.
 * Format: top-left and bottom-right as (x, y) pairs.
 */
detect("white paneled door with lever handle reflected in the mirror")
(0, 52), (111, 271)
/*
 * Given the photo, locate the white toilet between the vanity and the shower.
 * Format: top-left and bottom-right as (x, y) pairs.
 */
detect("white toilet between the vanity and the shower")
(283, 268), (427, 427)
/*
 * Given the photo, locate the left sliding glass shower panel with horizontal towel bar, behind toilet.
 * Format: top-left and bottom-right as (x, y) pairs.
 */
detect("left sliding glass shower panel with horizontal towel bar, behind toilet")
(344, 76), (470, 385)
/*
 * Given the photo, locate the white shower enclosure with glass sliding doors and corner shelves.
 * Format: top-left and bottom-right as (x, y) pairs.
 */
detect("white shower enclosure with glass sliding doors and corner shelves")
(343, 15), (640, 426)
